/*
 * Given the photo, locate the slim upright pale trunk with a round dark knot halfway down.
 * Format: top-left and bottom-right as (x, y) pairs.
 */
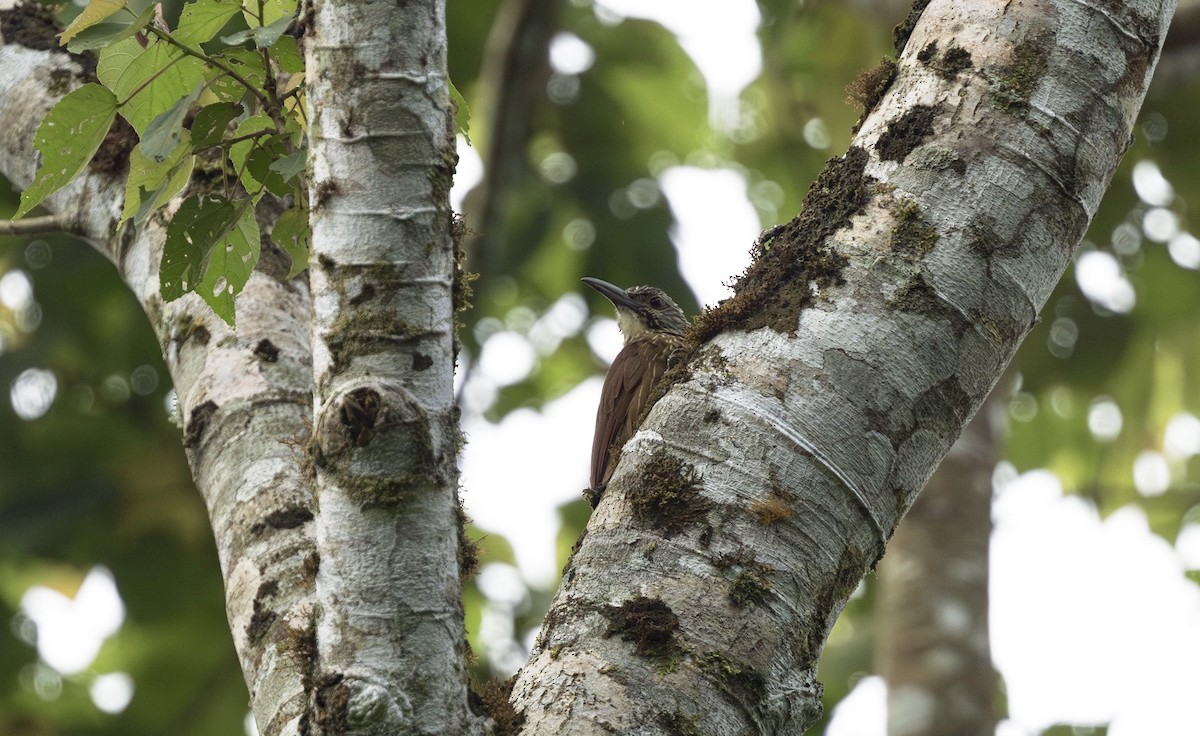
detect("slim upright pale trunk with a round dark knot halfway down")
(307, 0), (479, 735)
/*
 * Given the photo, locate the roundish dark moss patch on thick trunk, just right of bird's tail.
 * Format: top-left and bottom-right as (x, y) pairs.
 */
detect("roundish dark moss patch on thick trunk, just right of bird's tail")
(625, 450), (713, 537)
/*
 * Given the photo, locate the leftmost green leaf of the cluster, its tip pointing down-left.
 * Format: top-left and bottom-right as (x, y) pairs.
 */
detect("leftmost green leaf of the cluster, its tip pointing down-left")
(13, 84), (116, 220)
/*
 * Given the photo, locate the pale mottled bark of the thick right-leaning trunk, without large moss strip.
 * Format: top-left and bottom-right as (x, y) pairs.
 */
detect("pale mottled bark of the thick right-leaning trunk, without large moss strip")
(514, 0), (1174, 735)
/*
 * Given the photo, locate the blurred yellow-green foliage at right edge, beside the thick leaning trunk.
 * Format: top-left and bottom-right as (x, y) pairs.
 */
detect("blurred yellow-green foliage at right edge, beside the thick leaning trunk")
(1008, 74), (1200, 533)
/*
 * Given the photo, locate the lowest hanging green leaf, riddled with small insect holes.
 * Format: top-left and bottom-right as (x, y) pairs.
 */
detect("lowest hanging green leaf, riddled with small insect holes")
(158, 196), (259, 325)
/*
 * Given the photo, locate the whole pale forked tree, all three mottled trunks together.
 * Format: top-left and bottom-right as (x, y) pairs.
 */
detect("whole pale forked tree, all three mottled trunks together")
(0, 0), (1174, 736)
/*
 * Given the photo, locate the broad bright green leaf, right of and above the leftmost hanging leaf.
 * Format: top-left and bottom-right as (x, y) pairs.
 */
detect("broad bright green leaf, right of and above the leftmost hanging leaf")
(96, 38), (205, 136)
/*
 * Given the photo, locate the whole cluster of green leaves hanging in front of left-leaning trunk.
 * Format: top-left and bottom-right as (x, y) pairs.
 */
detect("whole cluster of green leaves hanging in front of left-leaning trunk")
(16, 0), (310, 325)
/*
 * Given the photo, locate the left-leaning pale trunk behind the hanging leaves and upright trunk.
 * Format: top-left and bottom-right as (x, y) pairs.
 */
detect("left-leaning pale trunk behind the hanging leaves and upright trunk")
(0, 35), (314, 734)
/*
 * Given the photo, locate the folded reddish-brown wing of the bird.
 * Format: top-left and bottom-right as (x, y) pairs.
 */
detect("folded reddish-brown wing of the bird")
(590, 335), (677, 489)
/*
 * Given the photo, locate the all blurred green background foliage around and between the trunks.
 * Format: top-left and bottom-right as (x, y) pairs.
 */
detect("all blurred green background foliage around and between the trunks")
(0, 0), (1200, 736)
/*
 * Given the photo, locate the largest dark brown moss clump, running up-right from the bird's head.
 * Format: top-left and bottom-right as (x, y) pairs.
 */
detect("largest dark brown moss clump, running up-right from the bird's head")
(689, 146), (875, 343)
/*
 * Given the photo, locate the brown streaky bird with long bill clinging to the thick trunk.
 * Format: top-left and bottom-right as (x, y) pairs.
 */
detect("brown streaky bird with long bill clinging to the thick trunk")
(582, 276), (688, 508)
